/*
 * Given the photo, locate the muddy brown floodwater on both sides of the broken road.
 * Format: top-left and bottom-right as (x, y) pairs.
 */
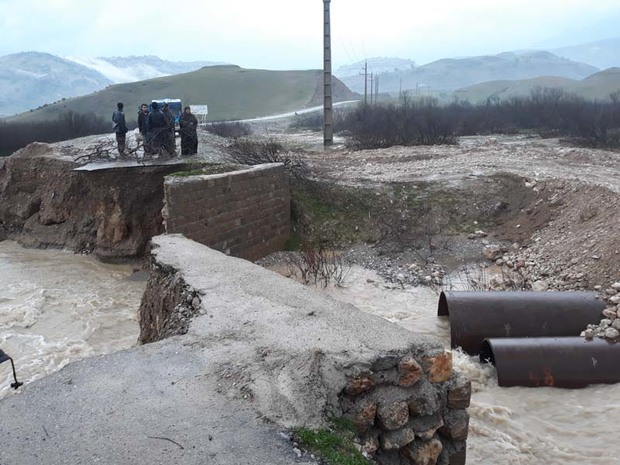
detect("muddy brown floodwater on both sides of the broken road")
(0, 245), (620, 465)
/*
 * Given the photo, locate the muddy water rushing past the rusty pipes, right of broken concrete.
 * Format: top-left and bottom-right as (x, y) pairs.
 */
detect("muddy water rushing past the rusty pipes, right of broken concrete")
(304, 267), (620, 465)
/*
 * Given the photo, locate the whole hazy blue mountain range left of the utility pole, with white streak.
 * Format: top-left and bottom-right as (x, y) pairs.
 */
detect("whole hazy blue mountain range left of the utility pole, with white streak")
(0, 52), (226, 117)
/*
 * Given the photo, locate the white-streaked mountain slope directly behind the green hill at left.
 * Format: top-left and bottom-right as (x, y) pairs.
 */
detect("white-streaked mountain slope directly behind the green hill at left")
(65, 55), (226, 84)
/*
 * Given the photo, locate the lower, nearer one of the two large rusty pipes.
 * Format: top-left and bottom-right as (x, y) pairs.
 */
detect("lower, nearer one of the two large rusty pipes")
(480, 337), (620, 388)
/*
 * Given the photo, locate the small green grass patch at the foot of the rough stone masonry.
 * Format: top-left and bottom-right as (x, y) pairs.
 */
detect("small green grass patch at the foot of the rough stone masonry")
(293, 418), (372, 465)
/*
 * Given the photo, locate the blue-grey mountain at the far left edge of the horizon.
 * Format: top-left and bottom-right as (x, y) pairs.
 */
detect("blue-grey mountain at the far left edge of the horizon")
(0, 52), (112, 116)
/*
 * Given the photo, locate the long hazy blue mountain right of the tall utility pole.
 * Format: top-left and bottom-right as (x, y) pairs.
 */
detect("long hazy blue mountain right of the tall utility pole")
(342, 51), (599, 94)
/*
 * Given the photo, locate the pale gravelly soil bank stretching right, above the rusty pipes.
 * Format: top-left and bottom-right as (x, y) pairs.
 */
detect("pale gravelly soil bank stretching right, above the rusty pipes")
(253, 125), (620, 290)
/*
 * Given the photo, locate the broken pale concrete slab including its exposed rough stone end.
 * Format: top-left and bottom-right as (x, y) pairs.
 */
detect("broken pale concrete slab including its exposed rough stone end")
(140, 235), (471, 464)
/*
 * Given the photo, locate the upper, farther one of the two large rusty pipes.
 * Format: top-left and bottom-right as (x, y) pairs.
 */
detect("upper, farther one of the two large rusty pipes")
(437, 291), (605, 355)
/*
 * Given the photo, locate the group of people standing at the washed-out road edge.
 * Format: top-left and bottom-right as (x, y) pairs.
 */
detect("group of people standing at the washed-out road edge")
(112, 102), (198, 157)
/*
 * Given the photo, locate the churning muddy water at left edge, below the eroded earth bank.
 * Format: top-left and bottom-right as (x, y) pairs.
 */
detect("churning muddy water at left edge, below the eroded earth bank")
(0, 241), (146, 398)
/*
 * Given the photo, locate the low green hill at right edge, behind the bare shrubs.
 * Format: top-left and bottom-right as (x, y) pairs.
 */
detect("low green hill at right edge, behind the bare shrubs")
(453, 68), (620, 103)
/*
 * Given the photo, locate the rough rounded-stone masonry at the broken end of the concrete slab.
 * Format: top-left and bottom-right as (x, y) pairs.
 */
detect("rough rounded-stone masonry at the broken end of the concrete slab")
(340, 351), (471, 465)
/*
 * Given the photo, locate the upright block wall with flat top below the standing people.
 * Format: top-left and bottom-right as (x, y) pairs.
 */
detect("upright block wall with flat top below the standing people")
(163, 163), (291, 260)
